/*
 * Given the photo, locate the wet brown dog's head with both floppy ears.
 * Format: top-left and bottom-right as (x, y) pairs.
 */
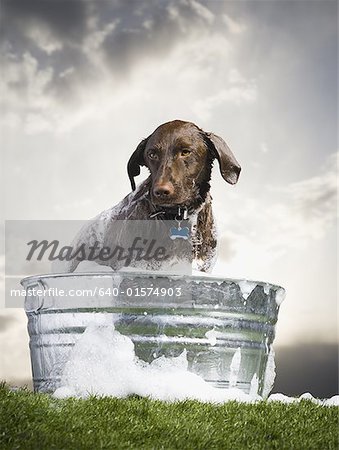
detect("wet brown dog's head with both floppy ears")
(127, 120), (241, 207)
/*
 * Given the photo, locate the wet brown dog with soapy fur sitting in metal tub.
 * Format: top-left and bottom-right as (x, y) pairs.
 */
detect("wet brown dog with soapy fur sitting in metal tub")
(67, 120), (241, 272)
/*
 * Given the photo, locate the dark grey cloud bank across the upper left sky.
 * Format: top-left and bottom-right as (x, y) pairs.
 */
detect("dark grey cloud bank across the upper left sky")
(2, 0), (213, 102)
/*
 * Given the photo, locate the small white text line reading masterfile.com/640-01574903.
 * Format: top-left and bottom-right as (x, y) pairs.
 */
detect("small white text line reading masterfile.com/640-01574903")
(10, 285), (182, 297)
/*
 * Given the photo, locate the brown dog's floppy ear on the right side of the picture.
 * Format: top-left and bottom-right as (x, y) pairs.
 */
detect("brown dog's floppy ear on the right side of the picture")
(205, 133), (241, 184)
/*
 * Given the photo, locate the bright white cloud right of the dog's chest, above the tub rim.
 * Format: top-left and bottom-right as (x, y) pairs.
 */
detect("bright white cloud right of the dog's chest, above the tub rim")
(216, 154), (337, 264)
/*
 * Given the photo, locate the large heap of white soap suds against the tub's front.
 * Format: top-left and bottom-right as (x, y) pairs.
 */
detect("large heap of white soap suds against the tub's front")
(54, 323), (260, 403)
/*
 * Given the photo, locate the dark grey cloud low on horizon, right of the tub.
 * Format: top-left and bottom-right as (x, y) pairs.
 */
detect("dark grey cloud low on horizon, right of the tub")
(273, 342), (339, 398)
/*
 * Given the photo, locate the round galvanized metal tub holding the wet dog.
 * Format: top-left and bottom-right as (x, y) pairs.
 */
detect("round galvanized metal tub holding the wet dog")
(21, 272), (284, 396)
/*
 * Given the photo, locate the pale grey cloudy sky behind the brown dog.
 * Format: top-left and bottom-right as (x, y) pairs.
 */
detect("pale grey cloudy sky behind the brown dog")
(0, 0), (337, 390)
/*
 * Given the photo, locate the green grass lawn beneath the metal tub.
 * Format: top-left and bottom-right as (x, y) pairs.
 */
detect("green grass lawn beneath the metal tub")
(0, 384), (339, 450)
